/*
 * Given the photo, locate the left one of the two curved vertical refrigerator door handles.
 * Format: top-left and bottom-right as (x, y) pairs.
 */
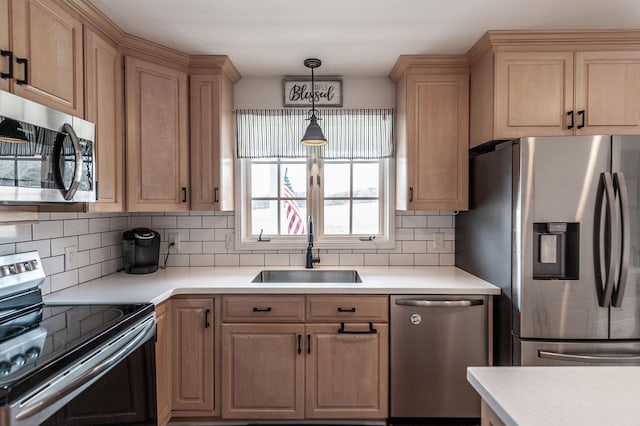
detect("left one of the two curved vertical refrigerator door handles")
(593, 172), (617, 308)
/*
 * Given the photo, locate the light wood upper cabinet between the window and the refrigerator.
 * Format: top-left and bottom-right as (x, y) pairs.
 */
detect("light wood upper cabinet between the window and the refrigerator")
(389, 56), (469, 210)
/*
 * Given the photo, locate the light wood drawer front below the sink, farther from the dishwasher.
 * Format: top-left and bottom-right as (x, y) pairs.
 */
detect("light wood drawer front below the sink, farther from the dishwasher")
(222, 296), (304, 322)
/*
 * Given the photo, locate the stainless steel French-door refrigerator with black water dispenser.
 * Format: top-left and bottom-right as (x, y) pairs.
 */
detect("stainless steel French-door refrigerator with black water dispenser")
(455, 136), (640, 365)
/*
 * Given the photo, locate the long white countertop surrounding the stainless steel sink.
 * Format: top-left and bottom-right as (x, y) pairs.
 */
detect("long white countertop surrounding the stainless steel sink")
(45, 266), (500, 304)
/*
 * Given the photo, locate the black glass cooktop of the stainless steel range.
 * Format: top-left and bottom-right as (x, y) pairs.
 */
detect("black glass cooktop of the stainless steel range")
(0, 304), (153, 404)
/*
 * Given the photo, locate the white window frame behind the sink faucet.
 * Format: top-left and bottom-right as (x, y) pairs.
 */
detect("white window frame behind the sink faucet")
(235, 157), (395, 251)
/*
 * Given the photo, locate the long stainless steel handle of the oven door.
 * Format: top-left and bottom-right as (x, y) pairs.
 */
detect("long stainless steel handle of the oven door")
(14, 316), (156, 422)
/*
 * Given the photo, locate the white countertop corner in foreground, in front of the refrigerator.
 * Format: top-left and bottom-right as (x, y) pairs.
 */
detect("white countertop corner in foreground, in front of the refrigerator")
(467, 367), (640, 426)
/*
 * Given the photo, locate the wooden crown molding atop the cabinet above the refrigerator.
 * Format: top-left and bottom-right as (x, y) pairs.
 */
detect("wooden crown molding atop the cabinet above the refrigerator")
(466, 29), (640, 64)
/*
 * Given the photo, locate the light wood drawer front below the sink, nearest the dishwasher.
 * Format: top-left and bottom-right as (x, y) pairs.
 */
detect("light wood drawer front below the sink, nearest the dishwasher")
(307, 296), (389, 322)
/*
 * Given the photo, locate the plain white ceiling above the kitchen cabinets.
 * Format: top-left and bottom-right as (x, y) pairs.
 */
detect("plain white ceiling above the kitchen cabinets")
(90, 0), (640, 77)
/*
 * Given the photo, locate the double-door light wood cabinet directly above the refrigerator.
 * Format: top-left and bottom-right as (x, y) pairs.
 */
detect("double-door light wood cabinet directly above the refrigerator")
(468, 31), (640, 147)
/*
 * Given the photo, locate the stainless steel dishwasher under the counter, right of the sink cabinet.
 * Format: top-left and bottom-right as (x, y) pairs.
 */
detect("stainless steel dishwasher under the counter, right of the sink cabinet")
(389, 295), (488, 419)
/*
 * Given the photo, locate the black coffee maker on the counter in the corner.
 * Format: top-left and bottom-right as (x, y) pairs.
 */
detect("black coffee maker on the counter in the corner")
(122, 228), (160, 274)
